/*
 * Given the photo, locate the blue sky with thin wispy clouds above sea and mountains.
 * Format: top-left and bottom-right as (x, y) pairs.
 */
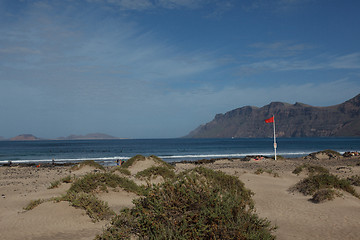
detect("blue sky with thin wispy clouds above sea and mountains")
(0, 0), (360, 138)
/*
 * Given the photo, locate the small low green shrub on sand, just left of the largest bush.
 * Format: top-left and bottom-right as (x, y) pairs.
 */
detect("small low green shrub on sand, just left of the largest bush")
(64, 192), (115, 222)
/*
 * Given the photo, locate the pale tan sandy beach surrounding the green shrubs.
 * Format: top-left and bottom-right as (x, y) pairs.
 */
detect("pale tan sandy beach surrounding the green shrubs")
(0, 157), (360, 239)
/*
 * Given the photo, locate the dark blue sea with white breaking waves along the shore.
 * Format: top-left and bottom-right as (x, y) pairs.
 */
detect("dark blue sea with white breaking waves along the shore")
(0, 138), (360, 165)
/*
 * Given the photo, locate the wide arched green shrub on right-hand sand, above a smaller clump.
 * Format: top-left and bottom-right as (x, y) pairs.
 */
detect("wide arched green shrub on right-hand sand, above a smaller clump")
(293, 173), (359, 198)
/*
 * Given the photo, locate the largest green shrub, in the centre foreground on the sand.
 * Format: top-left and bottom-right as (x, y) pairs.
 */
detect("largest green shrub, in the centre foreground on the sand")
(97, 168), (275, 239)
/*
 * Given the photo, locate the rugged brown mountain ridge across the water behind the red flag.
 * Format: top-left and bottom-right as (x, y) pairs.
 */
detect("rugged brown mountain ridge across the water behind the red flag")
(185, 94), (360, 138)
